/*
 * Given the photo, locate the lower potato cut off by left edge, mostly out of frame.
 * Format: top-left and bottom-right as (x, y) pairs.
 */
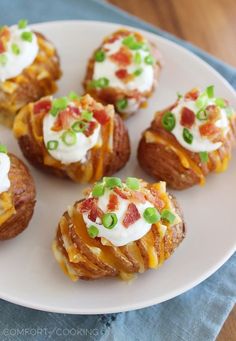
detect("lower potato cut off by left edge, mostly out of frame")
(0, 145), (35, 240)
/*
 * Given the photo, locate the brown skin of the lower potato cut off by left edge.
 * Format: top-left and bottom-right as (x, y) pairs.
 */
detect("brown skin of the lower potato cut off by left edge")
(0, 154), (36, 240)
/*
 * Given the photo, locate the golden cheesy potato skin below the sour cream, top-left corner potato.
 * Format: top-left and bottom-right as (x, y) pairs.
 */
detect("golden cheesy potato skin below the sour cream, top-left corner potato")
(0, 33), (61, 127)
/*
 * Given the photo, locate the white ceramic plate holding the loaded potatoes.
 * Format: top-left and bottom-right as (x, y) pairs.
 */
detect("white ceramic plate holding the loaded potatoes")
(0, 21), (236, 314)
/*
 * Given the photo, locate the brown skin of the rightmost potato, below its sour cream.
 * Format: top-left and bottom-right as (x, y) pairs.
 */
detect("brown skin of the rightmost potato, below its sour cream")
(138, 107), (236, 190)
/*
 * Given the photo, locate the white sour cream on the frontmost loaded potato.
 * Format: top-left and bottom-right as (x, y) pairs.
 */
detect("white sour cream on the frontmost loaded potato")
(83, 189), (154, 246)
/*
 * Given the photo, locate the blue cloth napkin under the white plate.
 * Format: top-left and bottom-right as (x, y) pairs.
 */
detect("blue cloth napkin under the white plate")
(0, 0), (236, 341)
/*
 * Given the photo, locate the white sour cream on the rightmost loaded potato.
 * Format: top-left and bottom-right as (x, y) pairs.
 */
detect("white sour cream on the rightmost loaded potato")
(171, 98), (229, 153)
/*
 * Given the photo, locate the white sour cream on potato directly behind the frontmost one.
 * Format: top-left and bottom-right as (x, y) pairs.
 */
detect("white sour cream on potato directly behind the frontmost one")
(43, 106), (101, 164)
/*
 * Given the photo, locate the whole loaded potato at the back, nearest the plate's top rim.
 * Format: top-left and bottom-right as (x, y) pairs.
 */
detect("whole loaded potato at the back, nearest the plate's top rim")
(84, 29), (161, 118)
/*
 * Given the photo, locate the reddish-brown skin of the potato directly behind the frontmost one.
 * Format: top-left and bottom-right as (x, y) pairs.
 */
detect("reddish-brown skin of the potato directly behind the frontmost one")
(14, 102), (130, 182)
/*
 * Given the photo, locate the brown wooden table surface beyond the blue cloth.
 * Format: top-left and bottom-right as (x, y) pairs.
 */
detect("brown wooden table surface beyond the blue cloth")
(108, 0), (236, 341)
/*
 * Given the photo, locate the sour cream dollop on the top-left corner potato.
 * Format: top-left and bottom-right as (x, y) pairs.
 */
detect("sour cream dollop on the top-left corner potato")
(0, 26), (39, 82)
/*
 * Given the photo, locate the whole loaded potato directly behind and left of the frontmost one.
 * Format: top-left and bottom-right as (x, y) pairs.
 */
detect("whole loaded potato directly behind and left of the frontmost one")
(13, 92), (130, 182)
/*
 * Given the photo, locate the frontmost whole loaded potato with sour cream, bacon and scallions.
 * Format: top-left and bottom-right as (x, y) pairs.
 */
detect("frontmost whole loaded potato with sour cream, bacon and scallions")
(53, 177), (185, 281)
